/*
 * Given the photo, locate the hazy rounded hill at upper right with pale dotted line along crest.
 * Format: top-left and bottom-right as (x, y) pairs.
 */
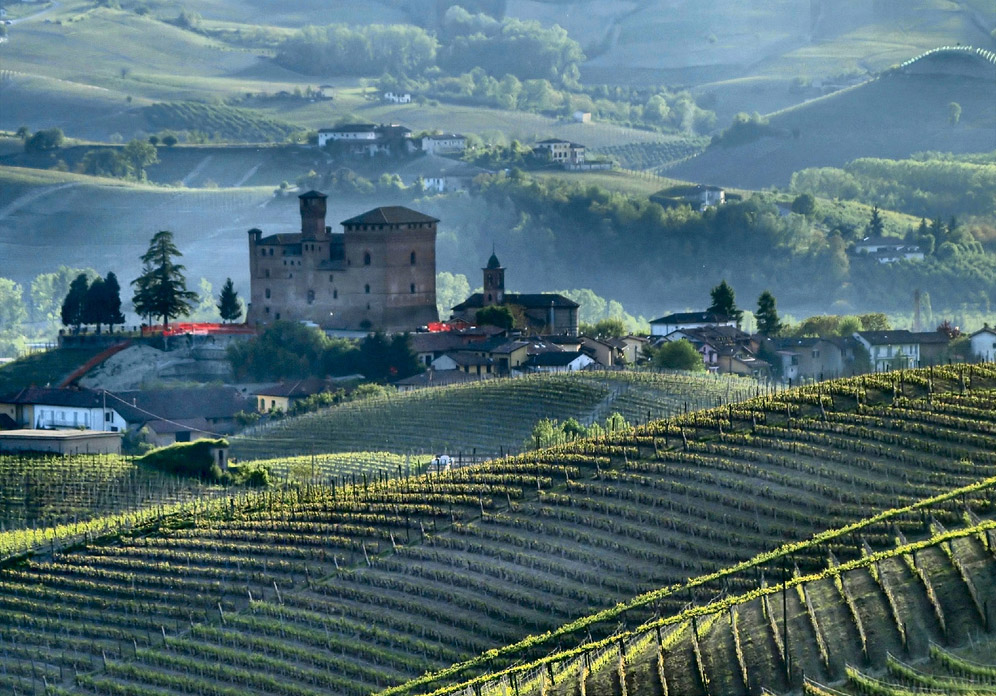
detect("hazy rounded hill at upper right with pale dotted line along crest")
(666, 51), (996, 189)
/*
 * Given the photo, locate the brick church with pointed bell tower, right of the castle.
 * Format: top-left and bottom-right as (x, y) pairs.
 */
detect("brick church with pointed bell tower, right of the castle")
(452, 253), (581, 336)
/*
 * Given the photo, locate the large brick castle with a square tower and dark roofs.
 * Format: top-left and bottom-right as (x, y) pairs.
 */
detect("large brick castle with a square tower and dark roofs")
(247, 191), (439, 332)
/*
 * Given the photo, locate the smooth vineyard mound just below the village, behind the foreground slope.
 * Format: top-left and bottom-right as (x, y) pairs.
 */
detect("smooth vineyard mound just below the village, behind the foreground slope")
(232, 372), (758, 459)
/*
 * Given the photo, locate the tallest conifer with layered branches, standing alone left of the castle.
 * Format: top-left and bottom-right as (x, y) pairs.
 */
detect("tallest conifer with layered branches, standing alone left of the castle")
(131, 230), (197, 327)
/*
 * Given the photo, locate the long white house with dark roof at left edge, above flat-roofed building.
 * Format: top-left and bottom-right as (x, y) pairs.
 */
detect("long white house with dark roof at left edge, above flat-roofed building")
(0, 387), (130, 433)
